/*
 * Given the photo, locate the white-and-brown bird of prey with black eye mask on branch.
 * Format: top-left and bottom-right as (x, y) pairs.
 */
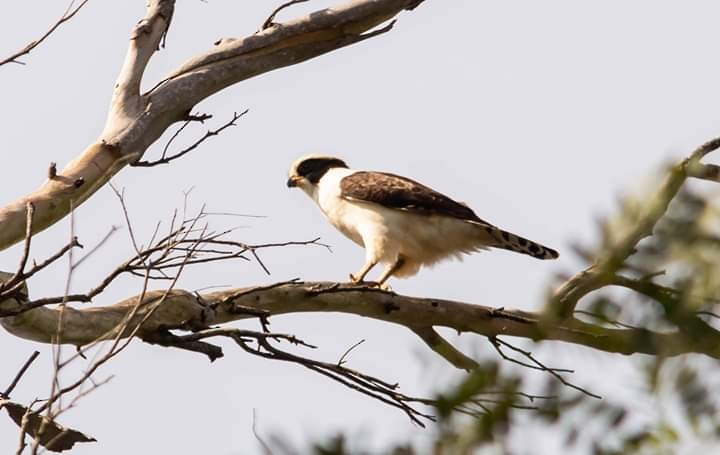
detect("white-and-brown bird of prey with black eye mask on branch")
(287, 155), (558, 286)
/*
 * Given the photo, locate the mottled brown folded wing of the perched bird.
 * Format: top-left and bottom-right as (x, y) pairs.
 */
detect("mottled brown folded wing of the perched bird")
(340, 171), (490, 225)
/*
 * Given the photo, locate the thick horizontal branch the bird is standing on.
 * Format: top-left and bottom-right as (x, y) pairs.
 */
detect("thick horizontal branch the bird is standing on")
(0, 283), (720, 358)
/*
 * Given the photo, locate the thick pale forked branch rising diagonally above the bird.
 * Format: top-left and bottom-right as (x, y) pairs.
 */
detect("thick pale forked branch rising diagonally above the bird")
(0, 0), (419, 251)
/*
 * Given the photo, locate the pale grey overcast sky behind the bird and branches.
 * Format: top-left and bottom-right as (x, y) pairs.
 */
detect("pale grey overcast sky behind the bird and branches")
(0, 0), (720, 455)
